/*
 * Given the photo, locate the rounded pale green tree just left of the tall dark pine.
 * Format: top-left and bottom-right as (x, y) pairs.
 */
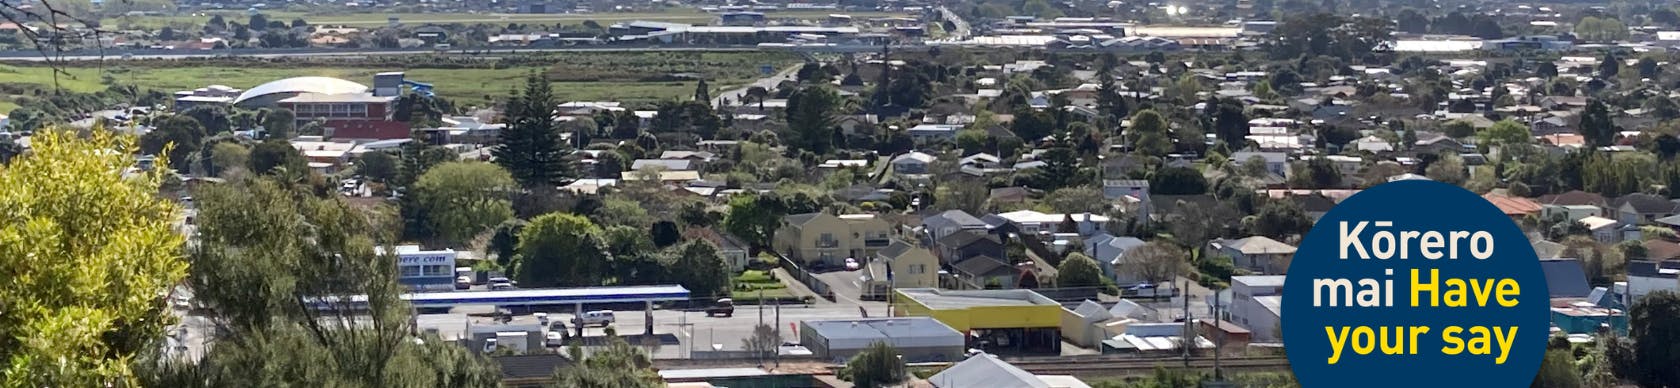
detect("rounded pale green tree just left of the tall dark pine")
(412, 161), (514, 245)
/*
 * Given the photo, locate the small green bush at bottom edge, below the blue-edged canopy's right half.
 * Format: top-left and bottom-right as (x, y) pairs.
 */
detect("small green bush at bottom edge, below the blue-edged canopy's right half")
(554, 336), (665, 388)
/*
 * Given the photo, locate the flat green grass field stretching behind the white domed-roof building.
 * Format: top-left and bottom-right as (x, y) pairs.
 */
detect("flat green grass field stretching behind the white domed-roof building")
(0, 52), (800, 113)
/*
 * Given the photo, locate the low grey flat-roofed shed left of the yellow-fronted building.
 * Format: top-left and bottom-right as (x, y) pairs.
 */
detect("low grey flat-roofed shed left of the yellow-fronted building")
(800, 317), (966, 363)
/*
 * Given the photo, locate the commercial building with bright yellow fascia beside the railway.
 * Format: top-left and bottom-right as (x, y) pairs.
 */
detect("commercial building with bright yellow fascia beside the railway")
(892, 289), (1062, 354)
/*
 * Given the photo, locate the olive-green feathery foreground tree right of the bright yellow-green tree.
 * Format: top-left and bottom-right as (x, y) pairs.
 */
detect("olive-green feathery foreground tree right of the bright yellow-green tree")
(143, 180), (501, 388)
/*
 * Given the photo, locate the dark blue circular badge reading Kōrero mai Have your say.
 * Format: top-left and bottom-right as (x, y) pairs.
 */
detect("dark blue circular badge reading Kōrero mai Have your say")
(1283, 180), (1551, 388)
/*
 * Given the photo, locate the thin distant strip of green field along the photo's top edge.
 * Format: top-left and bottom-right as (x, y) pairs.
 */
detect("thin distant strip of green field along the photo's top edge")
(101, 8), (906, 29)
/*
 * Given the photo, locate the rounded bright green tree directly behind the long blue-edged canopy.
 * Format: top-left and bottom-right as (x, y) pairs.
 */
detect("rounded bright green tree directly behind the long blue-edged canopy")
(512, 213), (612, 287)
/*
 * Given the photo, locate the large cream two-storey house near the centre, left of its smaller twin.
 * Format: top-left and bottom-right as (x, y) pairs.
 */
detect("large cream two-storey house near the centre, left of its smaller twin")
(773, 213), (892, 265)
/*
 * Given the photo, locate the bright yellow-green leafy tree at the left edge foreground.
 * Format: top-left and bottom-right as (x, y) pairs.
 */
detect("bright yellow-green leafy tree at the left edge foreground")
(0, 131), (186, 386)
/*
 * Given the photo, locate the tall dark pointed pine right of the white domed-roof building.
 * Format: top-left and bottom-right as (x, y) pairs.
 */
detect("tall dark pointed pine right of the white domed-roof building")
(491, 74), (571, 186)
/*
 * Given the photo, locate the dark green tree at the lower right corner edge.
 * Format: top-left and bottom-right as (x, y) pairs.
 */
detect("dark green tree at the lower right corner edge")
(1628, 291), (1680, 386)
